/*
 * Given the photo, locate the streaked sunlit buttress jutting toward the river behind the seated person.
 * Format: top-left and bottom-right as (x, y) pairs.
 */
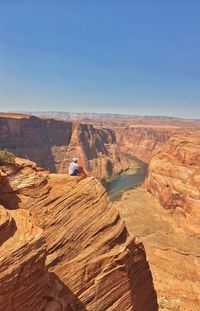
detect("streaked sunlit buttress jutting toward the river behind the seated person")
(58, 122), (128, 179)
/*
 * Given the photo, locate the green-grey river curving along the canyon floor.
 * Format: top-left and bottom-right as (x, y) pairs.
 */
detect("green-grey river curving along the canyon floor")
(103, 159), (147, 201)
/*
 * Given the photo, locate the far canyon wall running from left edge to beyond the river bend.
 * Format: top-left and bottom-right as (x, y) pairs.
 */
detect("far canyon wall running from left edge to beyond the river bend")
(0, 114), (178, 179)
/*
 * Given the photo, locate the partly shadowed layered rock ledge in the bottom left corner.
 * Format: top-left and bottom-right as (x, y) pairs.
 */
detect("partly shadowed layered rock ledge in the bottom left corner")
(0, 206), (70, 311)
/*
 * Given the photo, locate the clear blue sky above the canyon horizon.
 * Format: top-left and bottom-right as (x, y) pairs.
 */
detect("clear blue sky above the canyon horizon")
(0, 0), (200, 118)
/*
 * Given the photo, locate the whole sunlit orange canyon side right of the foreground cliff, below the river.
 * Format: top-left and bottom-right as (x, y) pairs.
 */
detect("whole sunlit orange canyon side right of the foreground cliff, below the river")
(116, 130), (200, 311)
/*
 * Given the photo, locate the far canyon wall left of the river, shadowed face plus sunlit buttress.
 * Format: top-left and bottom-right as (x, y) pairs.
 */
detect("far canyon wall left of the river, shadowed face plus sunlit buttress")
(0, 114), (127, 178)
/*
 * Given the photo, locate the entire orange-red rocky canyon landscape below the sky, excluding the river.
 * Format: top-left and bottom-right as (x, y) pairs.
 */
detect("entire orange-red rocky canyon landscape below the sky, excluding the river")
(0, 114), (200, 311)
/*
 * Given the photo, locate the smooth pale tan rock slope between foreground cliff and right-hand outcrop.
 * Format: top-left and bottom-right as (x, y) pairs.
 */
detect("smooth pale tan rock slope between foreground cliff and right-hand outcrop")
(115, 188), (200, 311)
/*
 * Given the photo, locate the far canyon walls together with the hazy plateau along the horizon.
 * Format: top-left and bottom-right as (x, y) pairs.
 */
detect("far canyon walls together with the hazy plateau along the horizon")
(0, 112), (200, 179)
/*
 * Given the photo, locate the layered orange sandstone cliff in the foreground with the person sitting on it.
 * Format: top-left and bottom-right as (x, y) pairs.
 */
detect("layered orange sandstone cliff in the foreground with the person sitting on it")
(0, 159), (157, 311)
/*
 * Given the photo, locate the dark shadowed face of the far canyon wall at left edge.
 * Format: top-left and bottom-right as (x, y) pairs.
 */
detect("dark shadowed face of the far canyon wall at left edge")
(0, 115), (72, 172)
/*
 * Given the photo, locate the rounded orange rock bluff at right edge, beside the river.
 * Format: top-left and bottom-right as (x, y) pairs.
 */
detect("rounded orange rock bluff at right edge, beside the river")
(145, 131), (200, 234)
